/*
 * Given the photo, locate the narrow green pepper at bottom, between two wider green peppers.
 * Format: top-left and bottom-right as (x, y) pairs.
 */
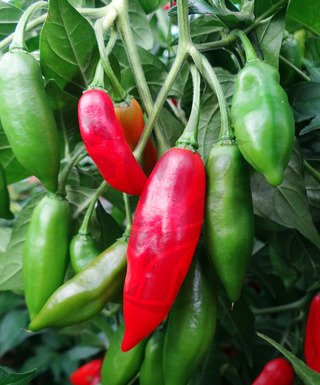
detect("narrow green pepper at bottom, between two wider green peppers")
(139, 330), (165, 385)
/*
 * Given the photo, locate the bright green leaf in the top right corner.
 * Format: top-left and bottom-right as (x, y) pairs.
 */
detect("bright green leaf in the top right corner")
(287, 0), (320, 34)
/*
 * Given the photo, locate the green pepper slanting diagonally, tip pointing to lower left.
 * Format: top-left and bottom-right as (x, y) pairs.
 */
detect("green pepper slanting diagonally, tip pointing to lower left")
(29, 238), (127, 331)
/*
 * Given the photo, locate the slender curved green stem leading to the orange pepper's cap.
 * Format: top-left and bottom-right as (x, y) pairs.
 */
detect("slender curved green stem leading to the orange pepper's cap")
(94, 19), (127, 102)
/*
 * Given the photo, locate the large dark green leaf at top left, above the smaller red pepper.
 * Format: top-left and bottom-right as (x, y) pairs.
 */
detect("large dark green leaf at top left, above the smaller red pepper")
(40, 0), (98, 94)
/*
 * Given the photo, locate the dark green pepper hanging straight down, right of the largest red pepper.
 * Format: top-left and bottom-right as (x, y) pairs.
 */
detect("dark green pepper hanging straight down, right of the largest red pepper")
(205, 139), (254, 302)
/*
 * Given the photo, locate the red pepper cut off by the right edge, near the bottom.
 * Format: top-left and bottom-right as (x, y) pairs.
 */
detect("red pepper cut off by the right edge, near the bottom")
(304, 294), (320, 373)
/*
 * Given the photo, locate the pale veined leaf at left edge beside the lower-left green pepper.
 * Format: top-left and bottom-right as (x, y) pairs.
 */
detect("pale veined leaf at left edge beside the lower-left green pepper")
(0, 193), (44, 294)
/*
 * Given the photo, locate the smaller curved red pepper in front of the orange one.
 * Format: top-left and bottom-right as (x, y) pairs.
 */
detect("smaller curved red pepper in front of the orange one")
(78, 89), (147, 196)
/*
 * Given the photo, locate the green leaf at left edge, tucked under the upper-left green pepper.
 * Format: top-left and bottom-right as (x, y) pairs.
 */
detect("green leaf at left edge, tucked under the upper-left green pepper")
(0, 123), (30, 185)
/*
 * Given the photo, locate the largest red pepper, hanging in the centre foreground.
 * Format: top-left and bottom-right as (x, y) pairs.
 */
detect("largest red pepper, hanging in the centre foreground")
(121, 148), (206, 351)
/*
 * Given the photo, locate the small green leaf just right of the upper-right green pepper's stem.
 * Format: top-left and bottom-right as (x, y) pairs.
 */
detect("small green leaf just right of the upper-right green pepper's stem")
(256, 10), (285, 68)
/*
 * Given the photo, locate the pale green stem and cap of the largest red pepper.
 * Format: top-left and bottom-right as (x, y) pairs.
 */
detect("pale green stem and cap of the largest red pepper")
(176, 64), (201, 151)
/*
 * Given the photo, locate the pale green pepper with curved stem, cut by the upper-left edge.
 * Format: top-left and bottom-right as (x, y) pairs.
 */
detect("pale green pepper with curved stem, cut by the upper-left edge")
(0, 2), (60, 192)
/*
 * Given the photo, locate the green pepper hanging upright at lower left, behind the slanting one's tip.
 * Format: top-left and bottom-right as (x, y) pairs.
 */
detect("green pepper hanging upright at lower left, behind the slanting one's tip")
(23, 194), (70, 320)
